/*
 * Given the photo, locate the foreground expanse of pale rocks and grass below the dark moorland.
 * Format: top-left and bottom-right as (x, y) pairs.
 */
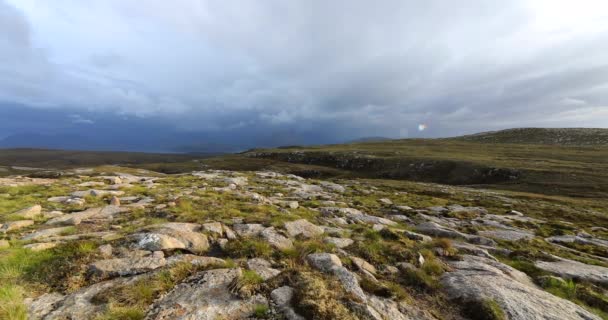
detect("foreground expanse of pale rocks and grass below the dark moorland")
(0, 166), (608, 320)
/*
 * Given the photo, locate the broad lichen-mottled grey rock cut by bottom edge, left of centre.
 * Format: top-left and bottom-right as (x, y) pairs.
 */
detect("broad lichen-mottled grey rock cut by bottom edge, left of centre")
(146, 269), (268, 320)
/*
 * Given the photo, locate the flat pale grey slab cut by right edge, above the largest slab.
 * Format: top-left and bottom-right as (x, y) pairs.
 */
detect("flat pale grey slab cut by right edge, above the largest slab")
(534, 257), (608, 285)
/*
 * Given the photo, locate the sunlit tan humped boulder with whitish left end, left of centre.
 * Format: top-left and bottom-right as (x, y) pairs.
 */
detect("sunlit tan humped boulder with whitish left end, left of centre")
(133, 224), (209, 254)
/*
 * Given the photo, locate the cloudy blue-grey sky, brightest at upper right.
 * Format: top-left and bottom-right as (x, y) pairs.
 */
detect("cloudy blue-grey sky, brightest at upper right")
(0, 0), (608, 148)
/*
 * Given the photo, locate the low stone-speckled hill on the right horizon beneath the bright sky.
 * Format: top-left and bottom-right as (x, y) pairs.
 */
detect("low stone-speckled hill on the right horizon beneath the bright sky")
(449, 128), (608, 146)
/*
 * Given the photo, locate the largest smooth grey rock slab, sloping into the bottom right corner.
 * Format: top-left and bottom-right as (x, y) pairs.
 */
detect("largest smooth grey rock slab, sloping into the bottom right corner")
(441, 255), (600, 320)
